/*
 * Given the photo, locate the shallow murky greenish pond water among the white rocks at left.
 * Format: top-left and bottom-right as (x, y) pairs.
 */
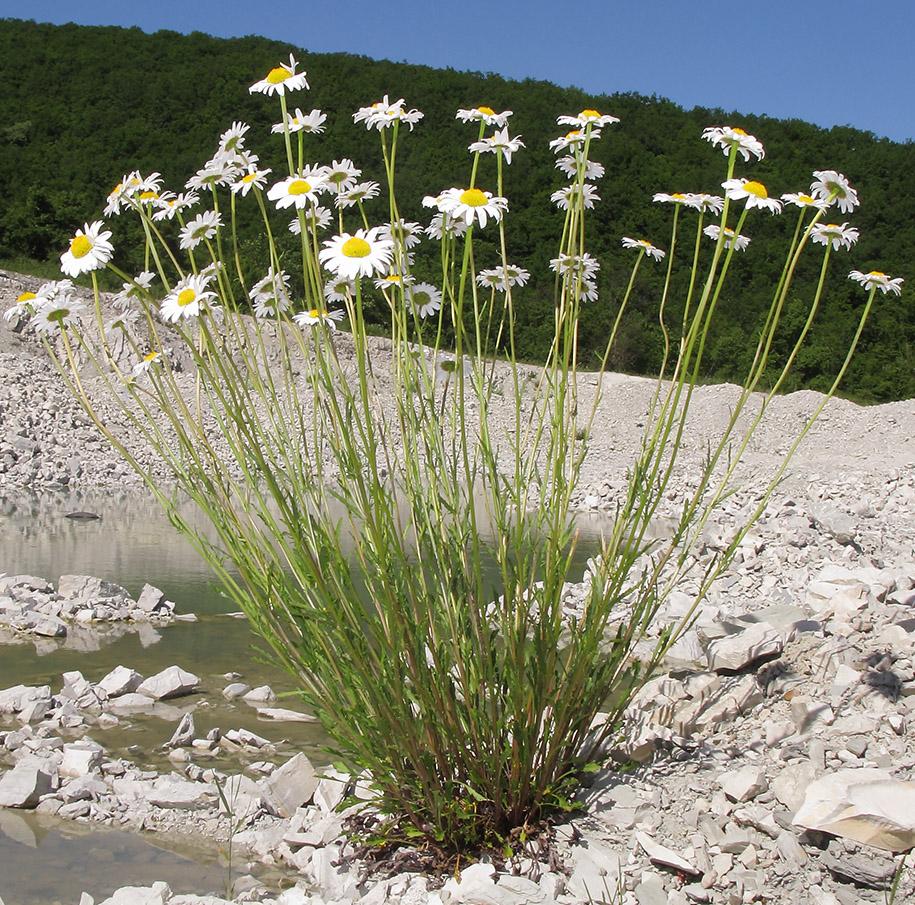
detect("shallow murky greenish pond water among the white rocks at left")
(0, 488), (606, 905)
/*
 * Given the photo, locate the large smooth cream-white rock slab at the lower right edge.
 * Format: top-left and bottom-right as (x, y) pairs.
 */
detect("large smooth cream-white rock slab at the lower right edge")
(794, 768), (915, 852)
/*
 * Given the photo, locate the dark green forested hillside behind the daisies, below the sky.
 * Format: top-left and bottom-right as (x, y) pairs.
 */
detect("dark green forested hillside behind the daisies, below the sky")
(0, 19), (915, 401)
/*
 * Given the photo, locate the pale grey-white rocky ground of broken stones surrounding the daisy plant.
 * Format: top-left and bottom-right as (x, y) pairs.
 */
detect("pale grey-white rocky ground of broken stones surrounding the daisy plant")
(0, 274), (915, 905)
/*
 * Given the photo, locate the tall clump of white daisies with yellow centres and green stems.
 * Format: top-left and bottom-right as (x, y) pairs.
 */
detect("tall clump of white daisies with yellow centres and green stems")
(37, 57), (902, 851)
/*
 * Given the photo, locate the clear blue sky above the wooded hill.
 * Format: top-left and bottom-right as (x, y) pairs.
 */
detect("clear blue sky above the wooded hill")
(8, 0), (915, 141)
